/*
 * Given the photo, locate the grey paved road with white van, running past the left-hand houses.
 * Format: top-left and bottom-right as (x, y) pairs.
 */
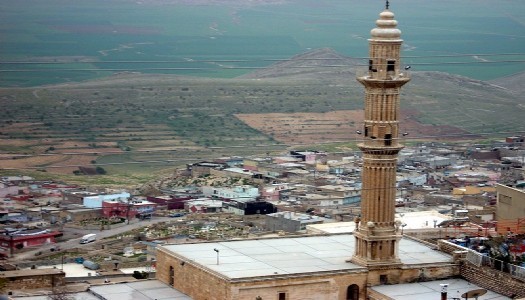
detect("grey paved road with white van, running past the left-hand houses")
(9, 217), (173, 263)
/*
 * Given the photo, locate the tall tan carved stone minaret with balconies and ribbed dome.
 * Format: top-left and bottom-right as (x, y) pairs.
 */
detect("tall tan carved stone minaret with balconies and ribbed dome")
(351, 1), (410, 268)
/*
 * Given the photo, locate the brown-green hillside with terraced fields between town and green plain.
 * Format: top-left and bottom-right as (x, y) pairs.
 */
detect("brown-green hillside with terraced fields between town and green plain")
(0, 49), (525, 183)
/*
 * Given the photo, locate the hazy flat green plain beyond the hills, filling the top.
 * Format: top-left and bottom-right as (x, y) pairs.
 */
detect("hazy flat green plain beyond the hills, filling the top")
(0, 0), (525, 87)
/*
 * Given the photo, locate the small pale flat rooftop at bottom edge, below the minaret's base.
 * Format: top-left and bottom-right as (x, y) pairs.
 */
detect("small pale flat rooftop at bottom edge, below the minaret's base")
(371, 278), (512, 300)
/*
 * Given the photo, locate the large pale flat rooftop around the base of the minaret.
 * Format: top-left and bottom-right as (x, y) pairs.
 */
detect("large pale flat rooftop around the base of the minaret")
(159, 234), (452, 279)
